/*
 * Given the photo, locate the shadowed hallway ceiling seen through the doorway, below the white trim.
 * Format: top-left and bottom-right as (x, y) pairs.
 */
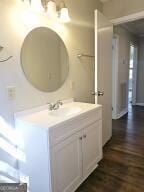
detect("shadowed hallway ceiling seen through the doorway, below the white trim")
(121, 19), (144, 36)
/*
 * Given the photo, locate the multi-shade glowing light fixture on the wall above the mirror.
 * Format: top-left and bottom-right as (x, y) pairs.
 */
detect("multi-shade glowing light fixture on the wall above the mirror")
(22, 0), (70, 23)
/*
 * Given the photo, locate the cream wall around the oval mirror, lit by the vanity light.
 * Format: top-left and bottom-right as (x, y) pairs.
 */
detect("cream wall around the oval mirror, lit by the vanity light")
(0, 0), (102, 122)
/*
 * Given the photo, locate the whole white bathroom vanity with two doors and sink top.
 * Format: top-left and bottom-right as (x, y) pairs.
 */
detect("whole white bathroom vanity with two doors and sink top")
(15, 102), (102, 192)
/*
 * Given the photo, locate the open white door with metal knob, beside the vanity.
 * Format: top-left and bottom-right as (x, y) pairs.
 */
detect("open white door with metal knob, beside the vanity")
(95, 10), (113, 145)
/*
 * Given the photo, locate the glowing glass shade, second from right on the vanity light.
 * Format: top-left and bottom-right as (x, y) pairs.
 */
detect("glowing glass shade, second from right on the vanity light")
(47, 0), (57, 17)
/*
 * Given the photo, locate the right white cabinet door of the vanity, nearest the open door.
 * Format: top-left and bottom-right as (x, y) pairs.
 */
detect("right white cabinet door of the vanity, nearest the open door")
(82, 121), (102, 178)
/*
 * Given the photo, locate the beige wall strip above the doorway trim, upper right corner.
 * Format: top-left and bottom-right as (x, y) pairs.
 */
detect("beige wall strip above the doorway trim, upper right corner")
(103, 0), (144, 19)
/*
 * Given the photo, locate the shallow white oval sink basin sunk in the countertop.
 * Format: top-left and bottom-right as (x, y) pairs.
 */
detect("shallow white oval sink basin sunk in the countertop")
(49, 107), (81, 117)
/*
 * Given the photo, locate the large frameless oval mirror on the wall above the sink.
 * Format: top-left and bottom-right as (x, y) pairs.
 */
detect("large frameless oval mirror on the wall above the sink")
(21, 27), (69, 92)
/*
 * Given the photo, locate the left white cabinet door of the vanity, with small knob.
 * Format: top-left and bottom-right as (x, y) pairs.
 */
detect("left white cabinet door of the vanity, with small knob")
(51, 131), (82, 192)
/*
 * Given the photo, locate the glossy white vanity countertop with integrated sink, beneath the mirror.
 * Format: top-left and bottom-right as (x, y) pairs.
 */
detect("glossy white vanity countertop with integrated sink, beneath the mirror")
(15, 102), (101, 128)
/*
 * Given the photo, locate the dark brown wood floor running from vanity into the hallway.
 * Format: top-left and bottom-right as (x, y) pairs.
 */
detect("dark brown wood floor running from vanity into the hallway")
(76, 107), (144, 192)
